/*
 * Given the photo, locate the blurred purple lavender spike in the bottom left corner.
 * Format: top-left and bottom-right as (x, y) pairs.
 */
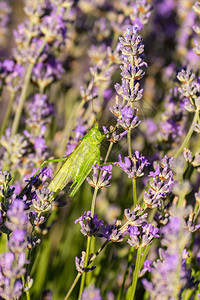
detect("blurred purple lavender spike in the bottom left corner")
(0, 199), (28, 299)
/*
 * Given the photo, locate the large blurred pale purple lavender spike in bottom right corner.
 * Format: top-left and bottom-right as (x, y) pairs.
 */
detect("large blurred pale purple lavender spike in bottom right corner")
(142, 213), (197, 299)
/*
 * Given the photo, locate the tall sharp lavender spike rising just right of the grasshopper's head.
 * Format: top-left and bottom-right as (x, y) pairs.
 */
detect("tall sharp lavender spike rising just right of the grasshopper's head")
(110, 26), (147, 135)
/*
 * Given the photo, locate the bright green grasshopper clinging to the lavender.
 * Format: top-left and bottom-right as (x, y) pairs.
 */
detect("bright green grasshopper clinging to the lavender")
(25, 125), (105, 200)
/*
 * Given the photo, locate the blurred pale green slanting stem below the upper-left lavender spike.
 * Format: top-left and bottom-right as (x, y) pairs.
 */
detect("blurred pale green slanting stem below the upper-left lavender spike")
(11, 63), (34, 136)
